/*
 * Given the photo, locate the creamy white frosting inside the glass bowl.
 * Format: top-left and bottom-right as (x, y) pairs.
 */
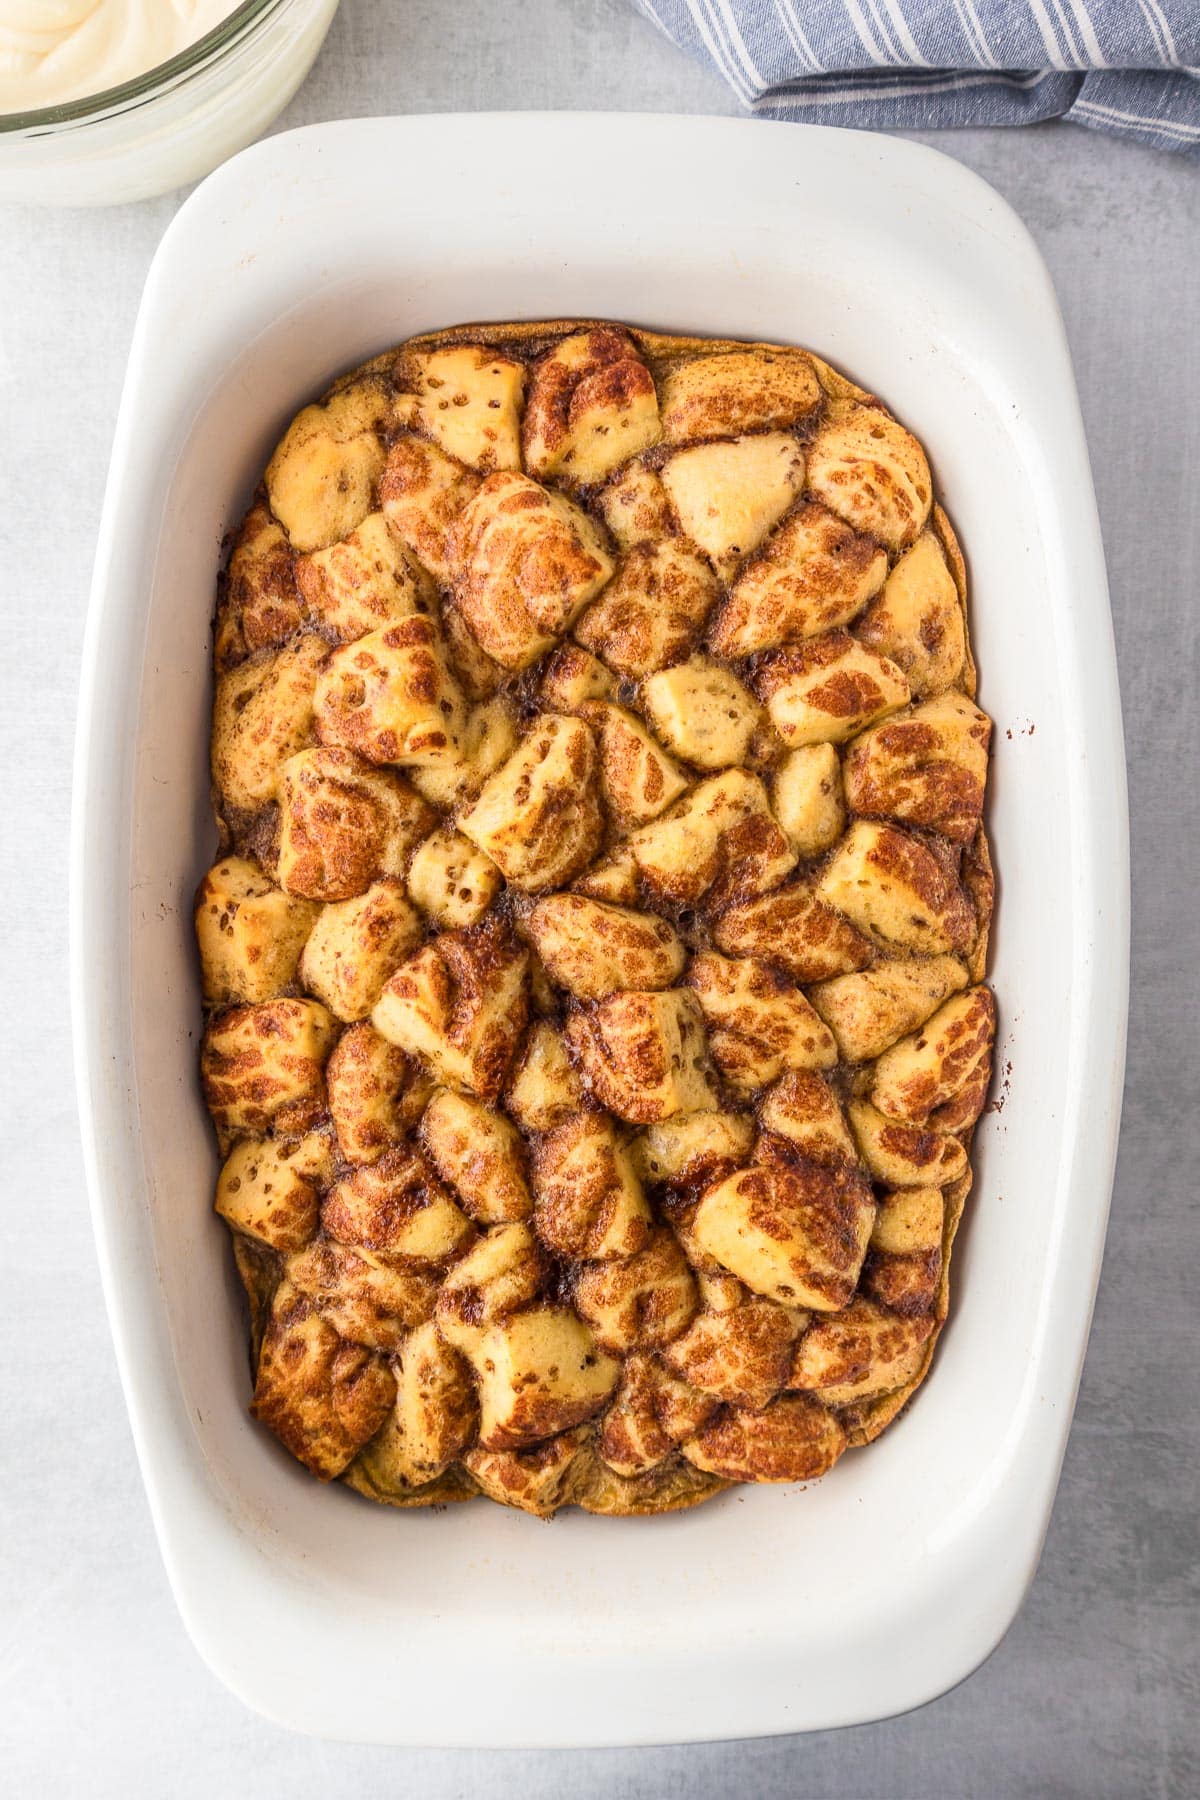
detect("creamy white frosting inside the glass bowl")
(0, 0), (239, 113)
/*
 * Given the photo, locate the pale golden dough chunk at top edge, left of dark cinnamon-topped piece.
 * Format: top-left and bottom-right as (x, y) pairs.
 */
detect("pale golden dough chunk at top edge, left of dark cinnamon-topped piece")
(394, 344), (525, 473)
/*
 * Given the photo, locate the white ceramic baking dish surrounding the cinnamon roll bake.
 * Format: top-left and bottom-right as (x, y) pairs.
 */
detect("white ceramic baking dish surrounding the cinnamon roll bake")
(72, 115), (1128, 1744)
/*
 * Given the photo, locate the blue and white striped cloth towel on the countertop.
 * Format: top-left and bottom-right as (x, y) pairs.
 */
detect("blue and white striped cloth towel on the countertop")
(635, 0), (1200, 155)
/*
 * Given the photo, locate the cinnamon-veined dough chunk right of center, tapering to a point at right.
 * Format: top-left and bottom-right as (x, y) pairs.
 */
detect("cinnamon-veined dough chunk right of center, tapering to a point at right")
(687, 950), (837, 1094)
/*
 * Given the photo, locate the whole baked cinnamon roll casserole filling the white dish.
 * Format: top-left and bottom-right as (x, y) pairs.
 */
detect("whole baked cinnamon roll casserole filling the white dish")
(196, 322), (995, 1514)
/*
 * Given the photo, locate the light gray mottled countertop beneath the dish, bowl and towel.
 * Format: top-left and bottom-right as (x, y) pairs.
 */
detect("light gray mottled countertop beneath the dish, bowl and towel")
(0, 0), (1200, 1800)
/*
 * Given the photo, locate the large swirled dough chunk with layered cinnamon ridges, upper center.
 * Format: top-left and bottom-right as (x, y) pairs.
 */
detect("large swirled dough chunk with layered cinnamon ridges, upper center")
(448, 473), (613, 670)
